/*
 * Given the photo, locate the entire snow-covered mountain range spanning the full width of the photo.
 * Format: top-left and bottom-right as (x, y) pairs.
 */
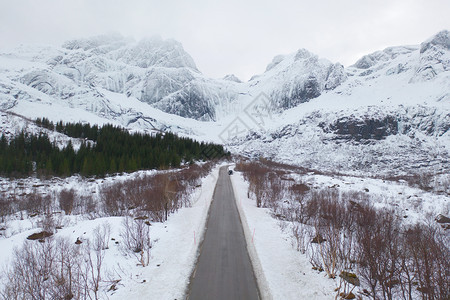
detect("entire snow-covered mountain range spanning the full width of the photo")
(0, 30), (450, 176)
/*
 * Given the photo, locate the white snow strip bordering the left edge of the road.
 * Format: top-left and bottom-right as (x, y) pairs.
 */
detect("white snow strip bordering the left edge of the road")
(110, 166), (220, 299)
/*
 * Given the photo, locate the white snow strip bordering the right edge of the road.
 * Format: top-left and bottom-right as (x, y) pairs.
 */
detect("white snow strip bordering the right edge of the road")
(231, 166), (337, 300)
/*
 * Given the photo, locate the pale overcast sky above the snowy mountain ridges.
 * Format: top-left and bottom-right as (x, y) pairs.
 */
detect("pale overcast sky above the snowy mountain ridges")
(0, 0), (450, 80)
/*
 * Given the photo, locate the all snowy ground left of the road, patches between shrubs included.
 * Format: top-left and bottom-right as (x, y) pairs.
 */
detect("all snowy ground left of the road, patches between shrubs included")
(0, 166), (224, 299)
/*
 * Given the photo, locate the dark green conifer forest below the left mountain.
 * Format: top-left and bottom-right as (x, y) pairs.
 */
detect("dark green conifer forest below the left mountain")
(0, 118), (229, 177)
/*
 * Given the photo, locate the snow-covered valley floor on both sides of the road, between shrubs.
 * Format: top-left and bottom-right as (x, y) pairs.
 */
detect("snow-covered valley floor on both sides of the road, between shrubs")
(0, 164), (450, 299)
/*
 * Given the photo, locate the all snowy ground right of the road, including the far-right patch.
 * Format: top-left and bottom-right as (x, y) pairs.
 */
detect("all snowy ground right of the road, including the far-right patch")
(231, 164), (450, 299)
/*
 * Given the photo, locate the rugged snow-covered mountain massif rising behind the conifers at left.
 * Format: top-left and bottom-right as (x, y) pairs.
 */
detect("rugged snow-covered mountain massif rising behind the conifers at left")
(1, 35), (237, 121)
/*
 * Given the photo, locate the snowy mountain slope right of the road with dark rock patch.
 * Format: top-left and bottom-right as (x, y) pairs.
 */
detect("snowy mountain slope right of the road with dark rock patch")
(232, 31), (450, 175)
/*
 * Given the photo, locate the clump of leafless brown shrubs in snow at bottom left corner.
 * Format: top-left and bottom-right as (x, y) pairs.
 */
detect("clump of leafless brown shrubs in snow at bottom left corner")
(0, 238), (108, 300)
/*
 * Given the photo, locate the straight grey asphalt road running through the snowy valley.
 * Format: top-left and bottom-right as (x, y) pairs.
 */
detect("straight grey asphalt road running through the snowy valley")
(188, 167), (259, 300)
